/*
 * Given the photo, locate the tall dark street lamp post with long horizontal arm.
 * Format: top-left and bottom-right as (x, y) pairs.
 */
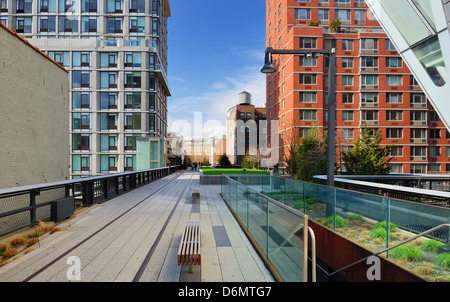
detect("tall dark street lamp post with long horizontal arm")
(261, 47), (336, 187)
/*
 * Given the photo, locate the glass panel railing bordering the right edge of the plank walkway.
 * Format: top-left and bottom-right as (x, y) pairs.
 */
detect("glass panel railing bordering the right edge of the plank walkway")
(221, 175), (308, 282)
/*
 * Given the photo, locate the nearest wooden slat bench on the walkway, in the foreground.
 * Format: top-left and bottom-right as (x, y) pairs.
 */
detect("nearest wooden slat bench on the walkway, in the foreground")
(178, 221), (201, 274)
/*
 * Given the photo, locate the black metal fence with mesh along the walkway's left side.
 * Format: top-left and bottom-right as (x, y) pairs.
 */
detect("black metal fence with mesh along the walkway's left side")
(0, 166), (179, 236)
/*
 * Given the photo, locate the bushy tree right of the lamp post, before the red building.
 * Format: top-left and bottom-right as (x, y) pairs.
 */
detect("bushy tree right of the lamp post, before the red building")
(342, 125), (392, 175)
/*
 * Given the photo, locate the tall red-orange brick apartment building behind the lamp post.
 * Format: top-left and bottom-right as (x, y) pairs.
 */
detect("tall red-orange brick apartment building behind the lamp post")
(266, 0), (450, 173)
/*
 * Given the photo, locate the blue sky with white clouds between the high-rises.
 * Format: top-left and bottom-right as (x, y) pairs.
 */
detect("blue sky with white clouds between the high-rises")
(168, 0), (265, 137)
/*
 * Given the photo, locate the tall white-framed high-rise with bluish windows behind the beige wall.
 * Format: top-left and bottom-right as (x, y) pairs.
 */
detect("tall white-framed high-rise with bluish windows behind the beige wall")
(0, 0), (171, 178)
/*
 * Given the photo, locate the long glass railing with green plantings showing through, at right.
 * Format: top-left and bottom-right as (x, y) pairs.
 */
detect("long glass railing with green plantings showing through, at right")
(222, 175), (450, 281)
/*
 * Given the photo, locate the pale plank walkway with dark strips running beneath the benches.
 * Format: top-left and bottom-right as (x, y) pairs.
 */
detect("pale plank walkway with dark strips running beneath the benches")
(0, 171), (274, 282)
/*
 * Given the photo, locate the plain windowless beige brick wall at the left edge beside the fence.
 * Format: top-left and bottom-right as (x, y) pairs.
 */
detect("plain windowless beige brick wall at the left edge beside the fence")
(0, 23), (70, 188)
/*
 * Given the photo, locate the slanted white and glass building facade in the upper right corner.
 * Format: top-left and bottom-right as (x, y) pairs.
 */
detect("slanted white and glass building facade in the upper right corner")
(366, 0), (450, 129)
